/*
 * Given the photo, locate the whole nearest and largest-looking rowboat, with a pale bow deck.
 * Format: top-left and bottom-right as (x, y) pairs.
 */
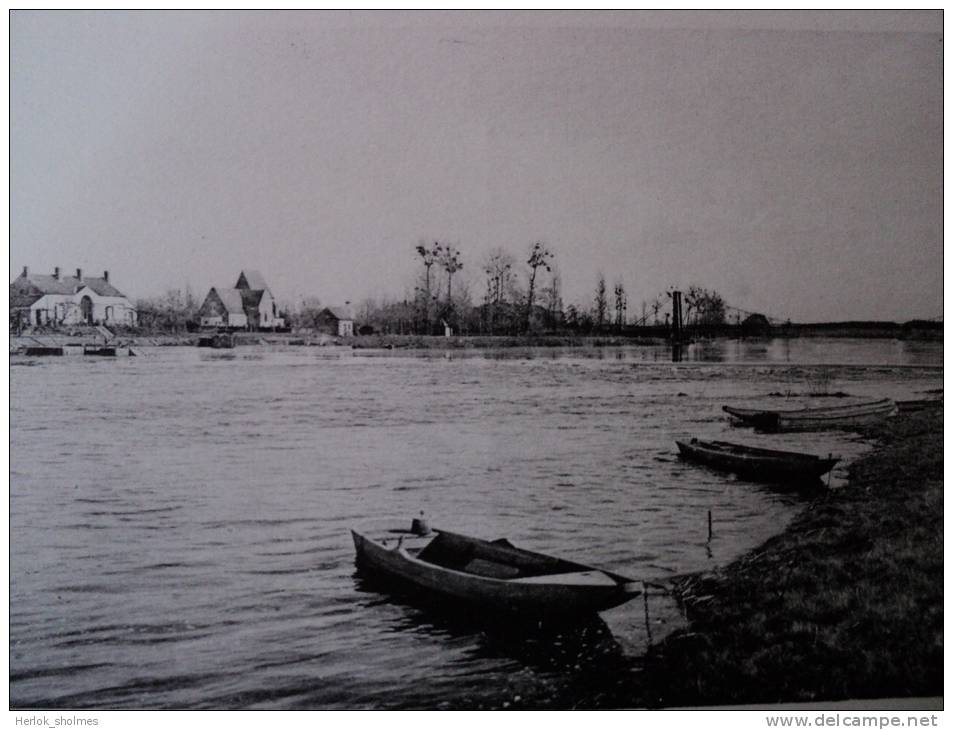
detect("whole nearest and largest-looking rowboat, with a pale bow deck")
(351, 530), (642, 618)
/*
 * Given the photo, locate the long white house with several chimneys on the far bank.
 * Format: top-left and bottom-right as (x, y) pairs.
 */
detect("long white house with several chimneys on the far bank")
(10, 266), (136, 327)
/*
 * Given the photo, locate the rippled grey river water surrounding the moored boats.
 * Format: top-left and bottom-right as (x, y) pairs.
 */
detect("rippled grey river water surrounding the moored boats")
(10, 339), (943, 709)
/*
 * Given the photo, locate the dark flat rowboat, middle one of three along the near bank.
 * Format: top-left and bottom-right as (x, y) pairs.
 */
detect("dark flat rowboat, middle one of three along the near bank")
(675, 438), (840, 482)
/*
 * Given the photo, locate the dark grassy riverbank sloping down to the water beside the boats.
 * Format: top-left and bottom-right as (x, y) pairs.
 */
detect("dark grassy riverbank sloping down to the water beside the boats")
(624, 408), (943, 707)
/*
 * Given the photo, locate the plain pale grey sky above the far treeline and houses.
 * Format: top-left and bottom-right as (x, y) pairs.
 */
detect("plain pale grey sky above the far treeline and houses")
(10, 11), (943, 322)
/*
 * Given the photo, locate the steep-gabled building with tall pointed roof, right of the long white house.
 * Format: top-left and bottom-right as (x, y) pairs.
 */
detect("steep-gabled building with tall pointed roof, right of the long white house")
(198, 270), (284, 330)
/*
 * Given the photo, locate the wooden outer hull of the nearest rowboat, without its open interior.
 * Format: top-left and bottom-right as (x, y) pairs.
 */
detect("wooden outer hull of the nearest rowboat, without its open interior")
(351, 530), (641, 618)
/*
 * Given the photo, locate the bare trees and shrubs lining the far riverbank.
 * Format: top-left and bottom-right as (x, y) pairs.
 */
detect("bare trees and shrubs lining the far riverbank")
(136, 241), (741, 335)
